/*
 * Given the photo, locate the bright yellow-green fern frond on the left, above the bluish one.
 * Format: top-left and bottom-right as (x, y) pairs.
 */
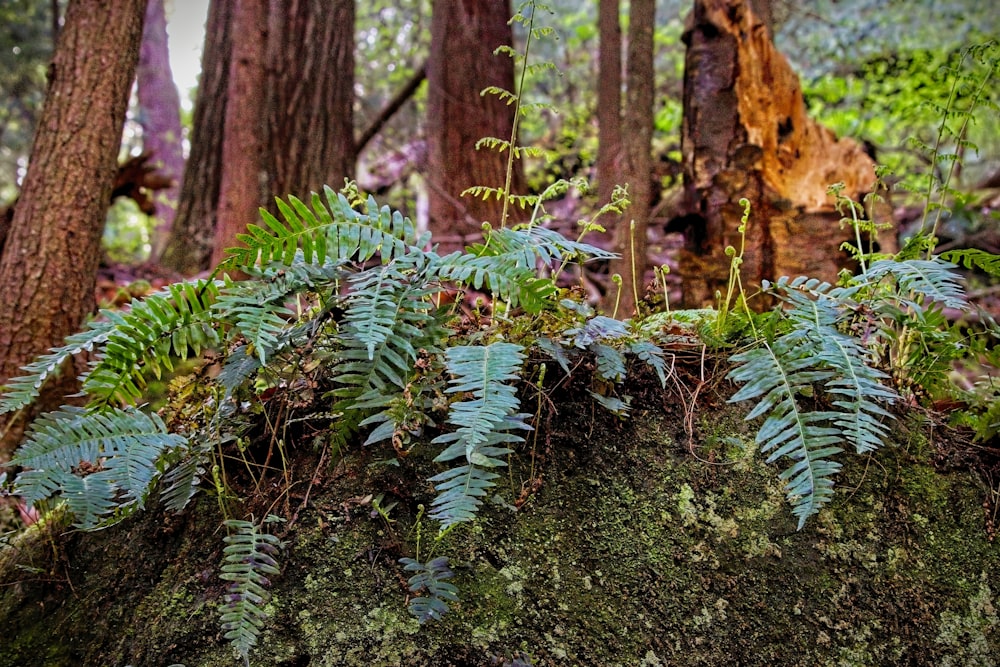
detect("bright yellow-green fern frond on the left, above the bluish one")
(83, 280), (221, 406)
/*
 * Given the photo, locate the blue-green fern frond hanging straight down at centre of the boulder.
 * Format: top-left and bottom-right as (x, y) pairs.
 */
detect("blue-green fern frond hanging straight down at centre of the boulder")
(430, 342), (530, 531)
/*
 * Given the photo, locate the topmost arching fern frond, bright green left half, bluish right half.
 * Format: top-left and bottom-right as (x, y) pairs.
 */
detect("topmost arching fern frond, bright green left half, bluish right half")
(226, 186), (424, 268)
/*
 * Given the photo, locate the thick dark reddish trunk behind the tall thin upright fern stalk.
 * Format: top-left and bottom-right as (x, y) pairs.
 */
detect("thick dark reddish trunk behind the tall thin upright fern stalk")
(427, 0), (523, 250)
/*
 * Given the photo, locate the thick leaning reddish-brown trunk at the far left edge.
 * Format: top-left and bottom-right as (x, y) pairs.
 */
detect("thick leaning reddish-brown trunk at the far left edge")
(0, 0), (146, 460)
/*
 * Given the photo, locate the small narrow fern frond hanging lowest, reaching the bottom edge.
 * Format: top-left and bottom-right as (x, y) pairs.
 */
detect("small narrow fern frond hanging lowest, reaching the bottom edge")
(219, 519), (282, 665)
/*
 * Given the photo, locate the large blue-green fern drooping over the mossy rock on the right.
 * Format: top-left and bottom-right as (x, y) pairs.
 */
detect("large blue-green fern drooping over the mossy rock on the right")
(727, 276), (897, 530)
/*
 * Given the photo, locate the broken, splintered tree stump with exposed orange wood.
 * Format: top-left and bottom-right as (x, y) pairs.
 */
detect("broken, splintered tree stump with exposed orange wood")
(679, 0), (875, 307)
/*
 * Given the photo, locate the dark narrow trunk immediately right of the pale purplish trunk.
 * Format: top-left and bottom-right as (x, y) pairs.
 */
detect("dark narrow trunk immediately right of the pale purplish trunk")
(160, 0), (235, 275)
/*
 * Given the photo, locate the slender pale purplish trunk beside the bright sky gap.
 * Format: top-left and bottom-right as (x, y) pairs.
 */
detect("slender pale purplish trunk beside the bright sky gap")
(136, 0), (184, 260)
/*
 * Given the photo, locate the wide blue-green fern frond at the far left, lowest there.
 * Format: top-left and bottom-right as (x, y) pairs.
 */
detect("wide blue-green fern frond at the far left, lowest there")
(11, 406), (187, 529)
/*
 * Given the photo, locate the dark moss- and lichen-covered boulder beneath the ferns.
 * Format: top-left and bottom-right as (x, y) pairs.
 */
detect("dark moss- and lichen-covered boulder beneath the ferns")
(0, 390), (1000, 667)
